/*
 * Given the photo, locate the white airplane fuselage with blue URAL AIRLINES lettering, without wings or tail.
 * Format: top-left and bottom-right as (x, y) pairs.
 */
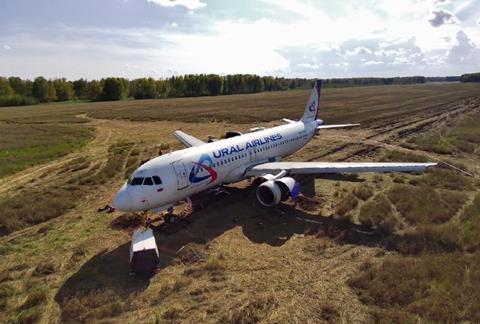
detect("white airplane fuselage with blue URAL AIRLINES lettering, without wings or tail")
(114, 120), (318, 211)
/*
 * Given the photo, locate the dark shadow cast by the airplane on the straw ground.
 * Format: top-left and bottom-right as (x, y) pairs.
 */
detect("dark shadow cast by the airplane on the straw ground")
(55, 182), (436, 321)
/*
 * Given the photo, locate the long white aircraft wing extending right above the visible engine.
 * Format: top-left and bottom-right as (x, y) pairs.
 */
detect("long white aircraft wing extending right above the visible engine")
(246, 162), (437, 176)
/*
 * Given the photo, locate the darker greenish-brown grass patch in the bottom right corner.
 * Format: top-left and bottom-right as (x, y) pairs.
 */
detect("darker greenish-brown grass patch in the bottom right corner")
(349, 253), (480, 323)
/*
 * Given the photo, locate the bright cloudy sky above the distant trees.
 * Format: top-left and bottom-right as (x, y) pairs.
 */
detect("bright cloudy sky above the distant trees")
(0, 0), (480, 80)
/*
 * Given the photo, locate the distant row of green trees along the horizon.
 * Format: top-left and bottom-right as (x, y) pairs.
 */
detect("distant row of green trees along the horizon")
(0, 74), (432, 106)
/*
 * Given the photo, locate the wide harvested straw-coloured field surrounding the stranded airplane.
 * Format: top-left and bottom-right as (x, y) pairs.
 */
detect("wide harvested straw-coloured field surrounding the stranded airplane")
(0, 83), (480, 322)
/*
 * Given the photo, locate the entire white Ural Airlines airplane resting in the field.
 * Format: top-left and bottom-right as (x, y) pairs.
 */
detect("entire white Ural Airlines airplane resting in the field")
(113, 80), (436, 219)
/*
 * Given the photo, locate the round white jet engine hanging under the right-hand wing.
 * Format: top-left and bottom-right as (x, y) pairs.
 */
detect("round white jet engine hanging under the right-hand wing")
(257, 175), (300, 207)
